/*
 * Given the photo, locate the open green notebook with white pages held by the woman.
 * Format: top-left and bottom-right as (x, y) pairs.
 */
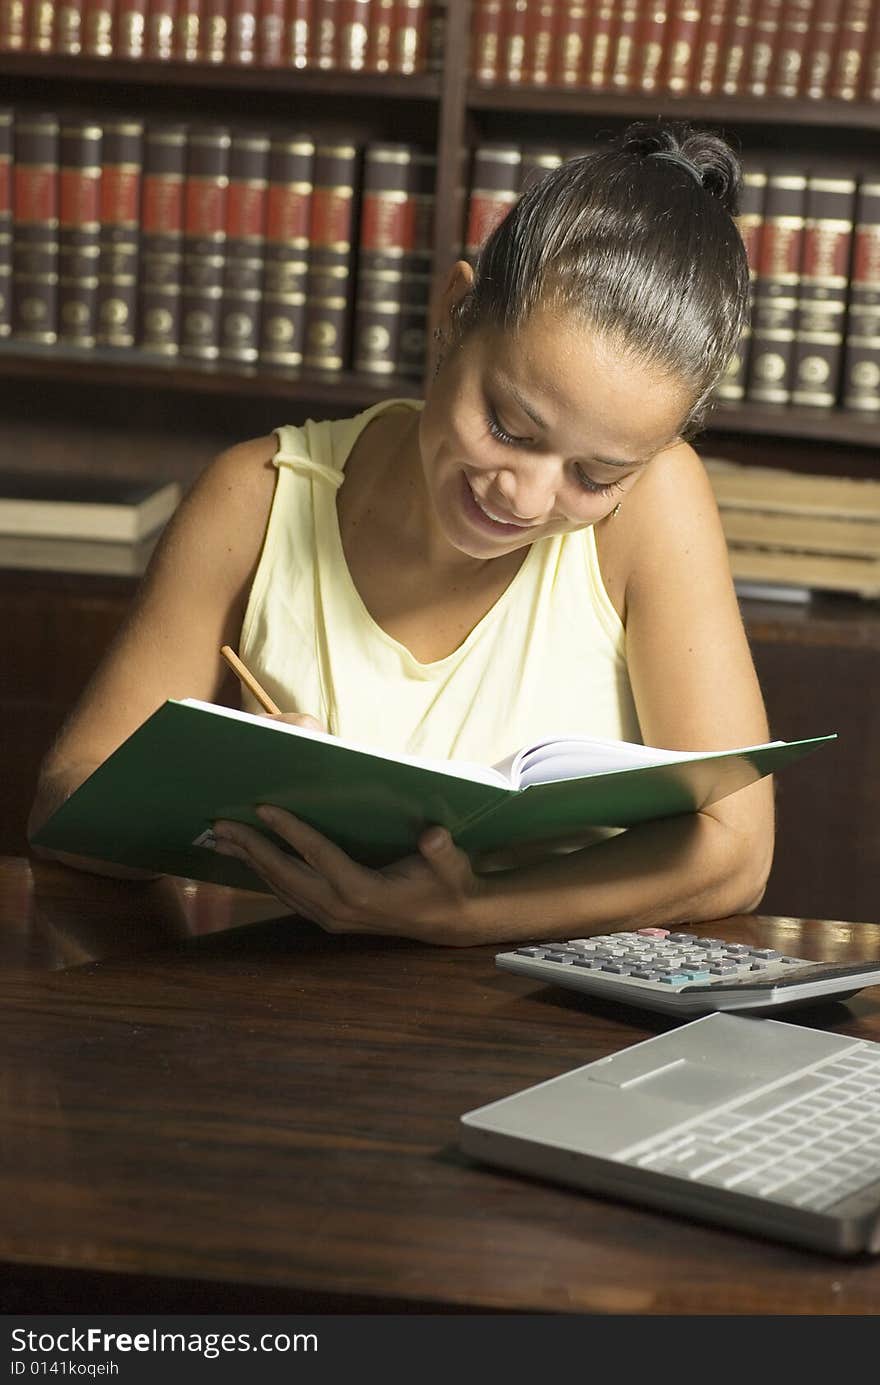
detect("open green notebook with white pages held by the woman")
(33, 699), (836, 889)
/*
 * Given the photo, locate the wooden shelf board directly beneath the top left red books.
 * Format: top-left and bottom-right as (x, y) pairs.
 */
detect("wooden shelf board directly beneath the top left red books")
(0, 53), (441, 101)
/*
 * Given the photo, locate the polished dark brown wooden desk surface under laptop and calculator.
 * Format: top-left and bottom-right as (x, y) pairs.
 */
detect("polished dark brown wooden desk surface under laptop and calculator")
(0, 857), (880, 1314)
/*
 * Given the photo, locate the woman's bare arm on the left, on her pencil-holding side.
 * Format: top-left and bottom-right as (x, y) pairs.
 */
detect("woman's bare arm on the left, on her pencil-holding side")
(28, 436), (276, 874)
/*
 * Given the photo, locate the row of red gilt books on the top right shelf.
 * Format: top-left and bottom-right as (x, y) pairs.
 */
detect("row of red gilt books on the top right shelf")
(471, 0), (880, 101)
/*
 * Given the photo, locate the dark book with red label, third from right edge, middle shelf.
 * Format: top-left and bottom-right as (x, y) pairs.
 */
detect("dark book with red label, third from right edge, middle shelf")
(746, 169), (807, 404)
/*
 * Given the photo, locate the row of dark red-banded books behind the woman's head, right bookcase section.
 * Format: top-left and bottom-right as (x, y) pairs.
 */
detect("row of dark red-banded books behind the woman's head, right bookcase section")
(464, 141), (880, 413)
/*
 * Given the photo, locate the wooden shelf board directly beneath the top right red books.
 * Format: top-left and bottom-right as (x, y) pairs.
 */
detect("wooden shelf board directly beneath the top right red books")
(467, 82), (880, 130)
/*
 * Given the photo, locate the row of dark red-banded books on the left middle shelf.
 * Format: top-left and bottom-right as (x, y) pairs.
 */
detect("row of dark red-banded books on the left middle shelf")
(0, 109), (435, 379)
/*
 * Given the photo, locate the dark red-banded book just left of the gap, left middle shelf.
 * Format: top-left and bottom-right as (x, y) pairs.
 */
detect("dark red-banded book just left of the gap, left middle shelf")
(302, 141), (358, 373)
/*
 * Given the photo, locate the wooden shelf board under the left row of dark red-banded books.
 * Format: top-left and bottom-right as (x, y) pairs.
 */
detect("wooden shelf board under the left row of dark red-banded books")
(0, 343), (421, 409)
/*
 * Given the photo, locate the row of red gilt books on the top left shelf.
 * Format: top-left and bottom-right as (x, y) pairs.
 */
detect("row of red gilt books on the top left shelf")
(0, 0), (443, 73)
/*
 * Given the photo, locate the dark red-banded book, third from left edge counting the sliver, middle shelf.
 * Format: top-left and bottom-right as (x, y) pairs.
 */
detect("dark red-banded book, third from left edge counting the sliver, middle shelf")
(58, 120), (103, 346)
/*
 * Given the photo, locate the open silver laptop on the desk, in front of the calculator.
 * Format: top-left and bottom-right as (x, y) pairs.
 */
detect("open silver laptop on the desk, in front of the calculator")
(460, 1014), (880, 1255)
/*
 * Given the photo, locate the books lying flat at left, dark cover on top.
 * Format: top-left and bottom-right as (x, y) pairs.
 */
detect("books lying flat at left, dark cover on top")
(0, 471), (180, 576)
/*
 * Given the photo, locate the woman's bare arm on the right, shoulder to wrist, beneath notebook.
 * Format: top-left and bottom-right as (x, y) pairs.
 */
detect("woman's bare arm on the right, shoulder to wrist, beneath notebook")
(457, 445), (773, 938)
